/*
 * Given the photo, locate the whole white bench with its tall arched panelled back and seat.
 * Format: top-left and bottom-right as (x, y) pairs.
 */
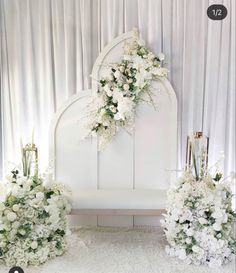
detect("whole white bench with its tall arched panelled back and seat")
(49, 32), (177, 225)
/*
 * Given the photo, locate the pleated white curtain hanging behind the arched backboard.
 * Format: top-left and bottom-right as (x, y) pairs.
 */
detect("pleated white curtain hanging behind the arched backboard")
(0, 0), (236, 176)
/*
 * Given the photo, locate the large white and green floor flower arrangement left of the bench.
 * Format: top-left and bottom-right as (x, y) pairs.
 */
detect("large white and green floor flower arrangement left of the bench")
(0, 171), (70, 266)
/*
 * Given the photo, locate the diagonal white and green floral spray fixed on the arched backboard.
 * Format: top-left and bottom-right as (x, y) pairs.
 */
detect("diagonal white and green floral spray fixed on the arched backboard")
(86, 30), (168, 150)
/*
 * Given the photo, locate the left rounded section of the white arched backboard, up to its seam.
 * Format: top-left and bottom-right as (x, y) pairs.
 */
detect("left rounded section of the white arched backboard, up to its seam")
(49, 90), (97, 189)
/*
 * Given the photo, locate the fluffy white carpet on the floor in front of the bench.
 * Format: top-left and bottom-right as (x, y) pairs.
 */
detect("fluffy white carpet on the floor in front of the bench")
(0, 228), (235, 273)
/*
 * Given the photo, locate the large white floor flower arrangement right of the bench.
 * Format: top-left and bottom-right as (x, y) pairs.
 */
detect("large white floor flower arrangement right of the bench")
(162, 166), (236, 267)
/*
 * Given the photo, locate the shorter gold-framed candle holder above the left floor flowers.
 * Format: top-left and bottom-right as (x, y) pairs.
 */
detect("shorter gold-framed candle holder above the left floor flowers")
(22, 143), (38, 177)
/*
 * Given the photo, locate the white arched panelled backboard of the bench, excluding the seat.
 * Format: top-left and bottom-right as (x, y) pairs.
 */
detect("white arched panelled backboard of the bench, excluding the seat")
(50, 32), (177, 225)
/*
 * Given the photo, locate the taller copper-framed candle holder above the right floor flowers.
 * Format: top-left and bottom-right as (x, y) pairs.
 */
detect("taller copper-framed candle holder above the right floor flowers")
(186, 132), (209, 180)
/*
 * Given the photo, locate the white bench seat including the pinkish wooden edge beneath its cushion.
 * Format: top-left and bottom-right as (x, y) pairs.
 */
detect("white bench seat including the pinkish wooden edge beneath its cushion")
(72, 189), (166, 215)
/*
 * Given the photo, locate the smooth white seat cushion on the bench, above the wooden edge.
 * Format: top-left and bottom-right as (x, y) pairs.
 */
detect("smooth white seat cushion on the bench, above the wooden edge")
(72, 189), (167, 209)
